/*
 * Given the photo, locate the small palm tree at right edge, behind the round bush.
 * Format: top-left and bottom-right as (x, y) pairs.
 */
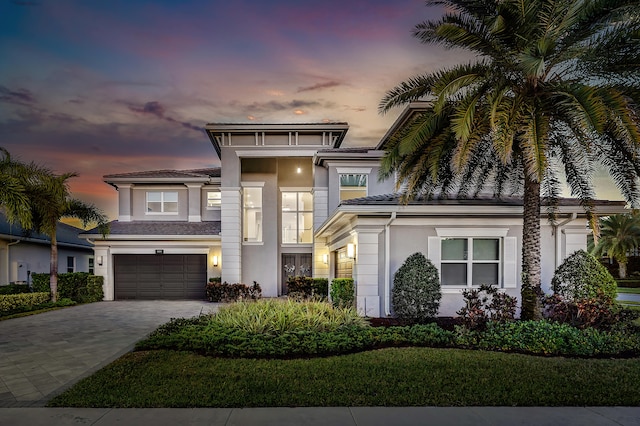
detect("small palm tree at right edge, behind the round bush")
(591, 214), (640, 278)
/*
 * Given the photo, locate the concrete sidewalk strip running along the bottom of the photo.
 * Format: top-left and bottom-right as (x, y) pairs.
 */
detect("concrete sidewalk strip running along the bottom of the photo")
(0, 407), (640, 426)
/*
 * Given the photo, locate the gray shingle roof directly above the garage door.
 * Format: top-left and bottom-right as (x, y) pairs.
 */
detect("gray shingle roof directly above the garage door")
(85, 220), (220, 239)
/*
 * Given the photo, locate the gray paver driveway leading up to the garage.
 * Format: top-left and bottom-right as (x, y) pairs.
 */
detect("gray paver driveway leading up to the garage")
(0, 300), (217, 407)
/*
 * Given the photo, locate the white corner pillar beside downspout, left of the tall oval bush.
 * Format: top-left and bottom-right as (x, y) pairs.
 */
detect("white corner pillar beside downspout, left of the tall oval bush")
(353, 228), (382, 317)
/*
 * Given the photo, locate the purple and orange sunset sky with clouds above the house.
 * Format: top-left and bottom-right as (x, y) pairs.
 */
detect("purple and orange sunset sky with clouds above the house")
(0, 0), (621, 218)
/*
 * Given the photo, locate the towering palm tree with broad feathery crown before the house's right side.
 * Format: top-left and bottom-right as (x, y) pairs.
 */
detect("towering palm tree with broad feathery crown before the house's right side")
(380, 0), (640, 318)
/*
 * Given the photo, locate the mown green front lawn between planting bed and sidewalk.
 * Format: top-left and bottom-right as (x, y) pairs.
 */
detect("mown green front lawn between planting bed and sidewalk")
(49, 348), (640, 407)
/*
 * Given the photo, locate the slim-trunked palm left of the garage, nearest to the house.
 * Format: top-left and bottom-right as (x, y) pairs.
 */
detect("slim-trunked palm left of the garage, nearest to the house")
(27, 173), (109, 302)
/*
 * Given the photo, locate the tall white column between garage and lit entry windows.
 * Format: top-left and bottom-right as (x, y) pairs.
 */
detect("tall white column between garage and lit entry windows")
(220, 188), (242, 284)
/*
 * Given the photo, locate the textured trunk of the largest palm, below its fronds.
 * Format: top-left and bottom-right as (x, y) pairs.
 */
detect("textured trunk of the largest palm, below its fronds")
(520, 175), (542, 320)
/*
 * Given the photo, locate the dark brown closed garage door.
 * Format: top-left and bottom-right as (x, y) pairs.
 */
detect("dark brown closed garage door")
(113, 254), (207, 300)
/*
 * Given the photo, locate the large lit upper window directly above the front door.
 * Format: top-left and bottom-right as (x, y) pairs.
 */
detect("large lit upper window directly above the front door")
(282, 191), (313, 244)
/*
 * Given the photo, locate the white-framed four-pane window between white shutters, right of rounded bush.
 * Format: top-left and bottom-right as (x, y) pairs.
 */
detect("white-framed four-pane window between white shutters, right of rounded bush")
(440, 237), (501, 287)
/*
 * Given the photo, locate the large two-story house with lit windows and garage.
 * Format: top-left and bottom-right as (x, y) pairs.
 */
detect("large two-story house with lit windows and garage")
(84, 104), (624, 317)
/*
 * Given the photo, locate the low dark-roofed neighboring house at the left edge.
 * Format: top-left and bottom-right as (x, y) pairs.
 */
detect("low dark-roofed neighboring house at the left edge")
(0, 213), (94, 285)
